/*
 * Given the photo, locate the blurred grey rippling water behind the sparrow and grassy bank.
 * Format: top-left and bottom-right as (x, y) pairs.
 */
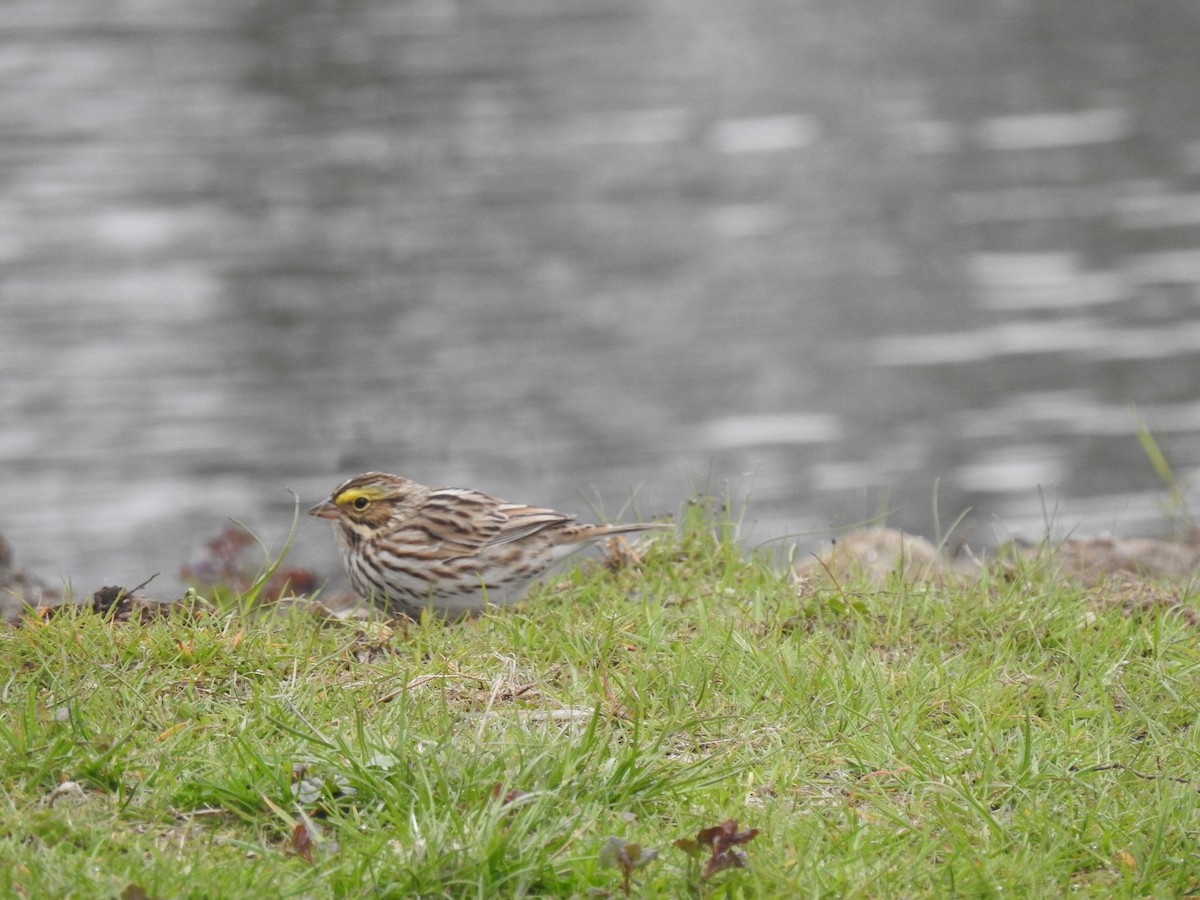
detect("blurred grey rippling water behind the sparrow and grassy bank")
(0, 0), (1200, 594)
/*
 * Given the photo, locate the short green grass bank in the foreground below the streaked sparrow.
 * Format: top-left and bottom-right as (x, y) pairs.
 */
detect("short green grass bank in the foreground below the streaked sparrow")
(0, 506), (1200, 898)
